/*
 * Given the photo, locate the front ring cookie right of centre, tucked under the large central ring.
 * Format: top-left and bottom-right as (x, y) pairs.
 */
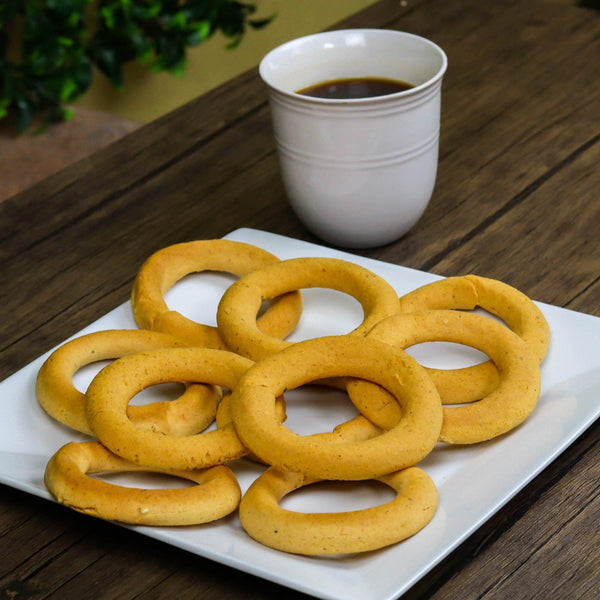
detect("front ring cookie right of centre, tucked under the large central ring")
(239, 416), (438, 556)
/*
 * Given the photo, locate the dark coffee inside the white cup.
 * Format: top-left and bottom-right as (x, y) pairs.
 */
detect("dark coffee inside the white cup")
(297, 77), (414, 100)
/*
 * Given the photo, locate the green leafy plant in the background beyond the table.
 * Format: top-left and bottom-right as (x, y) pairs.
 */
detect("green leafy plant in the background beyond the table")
(0, 0), (271, 132)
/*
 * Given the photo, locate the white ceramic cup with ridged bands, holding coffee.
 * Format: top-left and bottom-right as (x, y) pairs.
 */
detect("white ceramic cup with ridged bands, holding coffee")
(259, 29), (447, 248)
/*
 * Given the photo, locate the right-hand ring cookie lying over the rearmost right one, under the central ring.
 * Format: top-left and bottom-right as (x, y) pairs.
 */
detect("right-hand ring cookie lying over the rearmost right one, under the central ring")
(347, 310), (541, 444)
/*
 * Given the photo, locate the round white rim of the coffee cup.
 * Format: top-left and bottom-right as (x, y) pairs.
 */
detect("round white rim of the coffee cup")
(258, 27), (448, 105)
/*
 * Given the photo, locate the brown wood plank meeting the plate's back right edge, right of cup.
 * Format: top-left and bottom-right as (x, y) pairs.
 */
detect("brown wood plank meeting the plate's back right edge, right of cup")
(426, 139), (600, 316)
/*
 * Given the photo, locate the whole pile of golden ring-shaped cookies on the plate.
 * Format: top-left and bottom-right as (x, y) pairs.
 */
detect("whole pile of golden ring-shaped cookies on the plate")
(36, 240), (550, 556)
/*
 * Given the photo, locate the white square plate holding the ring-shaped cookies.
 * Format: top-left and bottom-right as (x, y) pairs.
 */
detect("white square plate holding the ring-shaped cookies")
(0, 229), (600, 600)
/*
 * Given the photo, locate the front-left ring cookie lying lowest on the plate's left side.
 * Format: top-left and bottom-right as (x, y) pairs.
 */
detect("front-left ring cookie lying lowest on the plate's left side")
(44, 442), (241, 526)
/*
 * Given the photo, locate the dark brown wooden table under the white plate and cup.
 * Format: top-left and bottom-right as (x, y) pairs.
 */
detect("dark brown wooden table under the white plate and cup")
(0, 0), (600, 600)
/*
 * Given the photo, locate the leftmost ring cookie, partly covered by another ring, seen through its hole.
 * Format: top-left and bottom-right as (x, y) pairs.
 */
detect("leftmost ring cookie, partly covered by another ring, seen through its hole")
(36, 329), (221, 435)
